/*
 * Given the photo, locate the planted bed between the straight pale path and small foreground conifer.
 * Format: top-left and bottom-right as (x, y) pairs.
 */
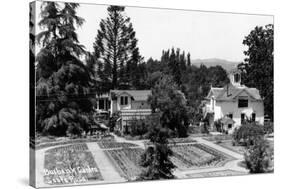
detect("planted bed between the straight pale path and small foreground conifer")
(106, 148), (143, 181)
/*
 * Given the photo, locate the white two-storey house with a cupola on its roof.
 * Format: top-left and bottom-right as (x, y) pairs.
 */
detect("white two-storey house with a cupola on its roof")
(203, 70), (264, 133)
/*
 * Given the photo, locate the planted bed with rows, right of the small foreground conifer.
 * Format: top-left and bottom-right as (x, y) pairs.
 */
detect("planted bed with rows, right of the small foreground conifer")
(171, 144), (230, 170)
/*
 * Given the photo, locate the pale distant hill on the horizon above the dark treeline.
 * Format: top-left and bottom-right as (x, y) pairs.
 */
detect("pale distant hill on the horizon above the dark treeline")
(191, 58), (240, 71)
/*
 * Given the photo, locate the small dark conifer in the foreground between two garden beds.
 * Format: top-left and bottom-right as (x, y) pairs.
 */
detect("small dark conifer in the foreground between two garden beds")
(138, 116), (175, 180)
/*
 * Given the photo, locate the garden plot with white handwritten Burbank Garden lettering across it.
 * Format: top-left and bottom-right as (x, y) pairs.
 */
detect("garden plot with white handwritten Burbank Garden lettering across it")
(44, 143), (103, 185)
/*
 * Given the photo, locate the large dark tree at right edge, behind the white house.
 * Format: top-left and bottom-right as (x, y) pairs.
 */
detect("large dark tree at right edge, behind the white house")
(238, 24), (274, 120)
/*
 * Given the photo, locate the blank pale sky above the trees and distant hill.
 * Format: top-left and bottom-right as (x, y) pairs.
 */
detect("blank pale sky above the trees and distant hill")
(34, 1), (273, 62)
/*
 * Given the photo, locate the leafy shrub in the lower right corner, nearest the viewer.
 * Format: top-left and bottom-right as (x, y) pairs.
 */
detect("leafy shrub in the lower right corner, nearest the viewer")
(244, 139), (273, 173)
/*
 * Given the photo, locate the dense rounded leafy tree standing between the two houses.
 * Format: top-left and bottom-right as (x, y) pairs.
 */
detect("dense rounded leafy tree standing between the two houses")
(148, 74), (191, 137)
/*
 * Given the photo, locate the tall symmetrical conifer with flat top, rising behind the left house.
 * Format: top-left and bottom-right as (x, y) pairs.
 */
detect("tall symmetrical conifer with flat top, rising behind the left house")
(93, 6), (142, 89)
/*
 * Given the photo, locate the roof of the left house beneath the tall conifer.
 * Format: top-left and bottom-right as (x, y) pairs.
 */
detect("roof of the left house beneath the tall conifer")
(110, 90), (151, 101)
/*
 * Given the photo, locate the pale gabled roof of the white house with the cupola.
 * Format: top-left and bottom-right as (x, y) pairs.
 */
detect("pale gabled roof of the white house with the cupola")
(207, 84), (262, 100)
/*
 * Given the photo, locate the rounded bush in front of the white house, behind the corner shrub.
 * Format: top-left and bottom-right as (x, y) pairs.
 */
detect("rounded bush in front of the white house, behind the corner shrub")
(233, 123), (264, 146)
